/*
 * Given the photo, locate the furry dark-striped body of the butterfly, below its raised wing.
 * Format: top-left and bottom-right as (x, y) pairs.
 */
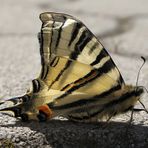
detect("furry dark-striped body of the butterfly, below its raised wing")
(50, 86), (143, 122)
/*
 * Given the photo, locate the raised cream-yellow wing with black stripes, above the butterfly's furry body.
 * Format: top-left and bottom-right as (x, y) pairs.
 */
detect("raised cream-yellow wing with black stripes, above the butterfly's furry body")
(37, 13), (124, 94)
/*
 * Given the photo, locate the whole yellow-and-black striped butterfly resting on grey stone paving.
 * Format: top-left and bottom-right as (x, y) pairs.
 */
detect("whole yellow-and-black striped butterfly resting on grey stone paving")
(0, 12), (144, 122)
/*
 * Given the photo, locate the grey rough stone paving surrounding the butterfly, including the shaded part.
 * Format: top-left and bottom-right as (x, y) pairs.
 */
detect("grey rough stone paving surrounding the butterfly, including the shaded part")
(0, 0), (148, 148)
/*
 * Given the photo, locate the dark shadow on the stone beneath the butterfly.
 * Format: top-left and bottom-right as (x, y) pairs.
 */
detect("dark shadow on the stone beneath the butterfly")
(1, 117), (148, 148)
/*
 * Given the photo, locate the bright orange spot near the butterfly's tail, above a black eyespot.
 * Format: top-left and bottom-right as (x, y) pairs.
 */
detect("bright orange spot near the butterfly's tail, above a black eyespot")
(38, 105), (53, 118)
